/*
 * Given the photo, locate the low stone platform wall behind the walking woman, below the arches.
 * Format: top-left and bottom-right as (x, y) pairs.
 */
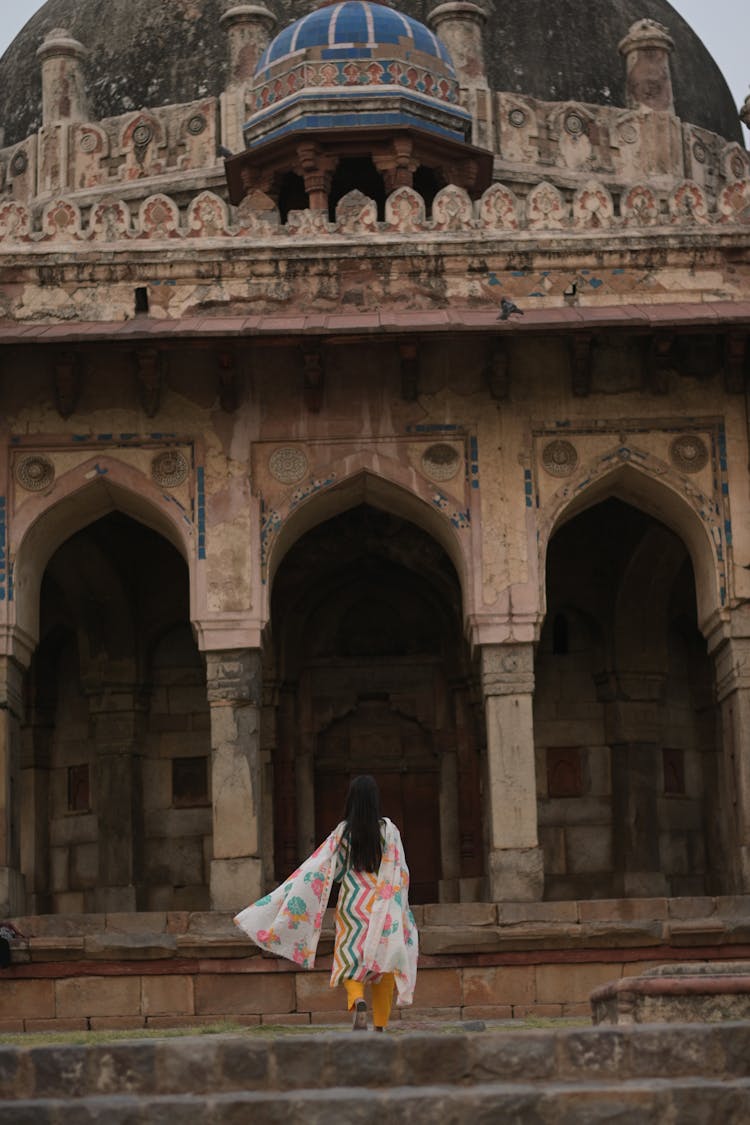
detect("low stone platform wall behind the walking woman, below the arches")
(0, 897), (750, 1032)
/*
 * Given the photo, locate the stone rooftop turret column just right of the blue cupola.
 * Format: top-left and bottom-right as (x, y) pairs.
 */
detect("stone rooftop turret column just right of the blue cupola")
(428, 0), (493, 149)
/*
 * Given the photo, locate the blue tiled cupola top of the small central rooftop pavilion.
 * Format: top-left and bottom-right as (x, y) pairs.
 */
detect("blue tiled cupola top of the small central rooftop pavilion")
(256, 0), (454, 79)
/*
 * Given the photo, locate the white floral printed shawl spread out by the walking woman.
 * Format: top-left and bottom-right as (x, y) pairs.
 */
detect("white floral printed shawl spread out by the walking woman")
(234, 818), (418, 1007)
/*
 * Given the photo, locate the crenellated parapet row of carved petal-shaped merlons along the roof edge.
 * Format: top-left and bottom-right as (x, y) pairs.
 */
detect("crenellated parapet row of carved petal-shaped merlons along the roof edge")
(0, 177), (750, 251)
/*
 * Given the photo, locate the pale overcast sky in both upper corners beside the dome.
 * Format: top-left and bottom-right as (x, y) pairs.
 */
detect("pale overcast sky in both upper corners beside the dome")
(0, 0), (750, 138)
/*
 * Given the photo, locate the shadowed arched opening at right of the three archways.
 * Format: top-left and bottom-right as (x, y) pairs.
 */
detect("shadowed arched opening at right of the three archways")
(534, 498), (724, 899)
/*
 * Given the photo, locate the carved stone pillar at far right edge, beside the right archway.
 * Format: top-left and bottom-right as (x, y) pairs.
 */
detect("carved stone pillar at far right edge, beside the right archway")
(710, 637), (750, 894)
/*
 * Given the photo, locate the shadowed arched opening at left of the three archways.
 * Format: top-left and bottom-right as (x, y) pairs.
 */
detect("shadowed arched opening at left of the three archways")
(21, 512), (211, 914)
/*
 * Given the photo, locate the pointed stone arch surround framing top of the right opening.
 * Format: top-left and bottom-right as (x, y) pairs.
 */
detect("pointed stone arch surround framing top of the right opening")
(539, 457), (726, 635)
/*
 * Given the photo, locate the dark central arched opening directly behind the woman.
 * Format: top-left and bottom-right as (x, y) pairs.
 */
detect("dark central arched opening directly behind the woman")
(266, 504), (482, 902)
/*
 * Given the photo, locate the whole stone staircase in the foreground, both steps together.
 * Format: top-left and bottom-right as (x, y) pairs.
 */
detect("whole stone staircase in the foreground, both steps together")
(0, 1022), (750, 1125)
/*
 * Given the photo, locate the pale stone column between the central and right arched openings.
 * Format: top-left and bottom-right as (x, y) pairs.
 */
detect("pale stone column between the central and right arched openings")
(481, 644), (544, 902)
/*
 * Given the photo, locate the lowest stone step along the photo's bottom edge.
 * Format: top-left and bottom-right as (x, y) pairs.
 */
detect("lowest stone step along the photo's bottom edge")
(0, 1079), (750, 1125)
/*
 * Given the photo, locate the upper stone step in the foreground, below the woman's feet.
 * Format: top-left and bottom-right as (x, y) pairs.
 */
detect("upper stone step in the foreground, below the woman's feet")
(0, 1022), (750, 1098)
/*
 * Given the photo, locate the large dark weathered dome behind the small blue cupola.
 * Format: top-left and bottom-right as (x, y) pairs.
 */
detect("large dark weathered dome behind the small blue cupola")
(0, 0), (742, 144)
